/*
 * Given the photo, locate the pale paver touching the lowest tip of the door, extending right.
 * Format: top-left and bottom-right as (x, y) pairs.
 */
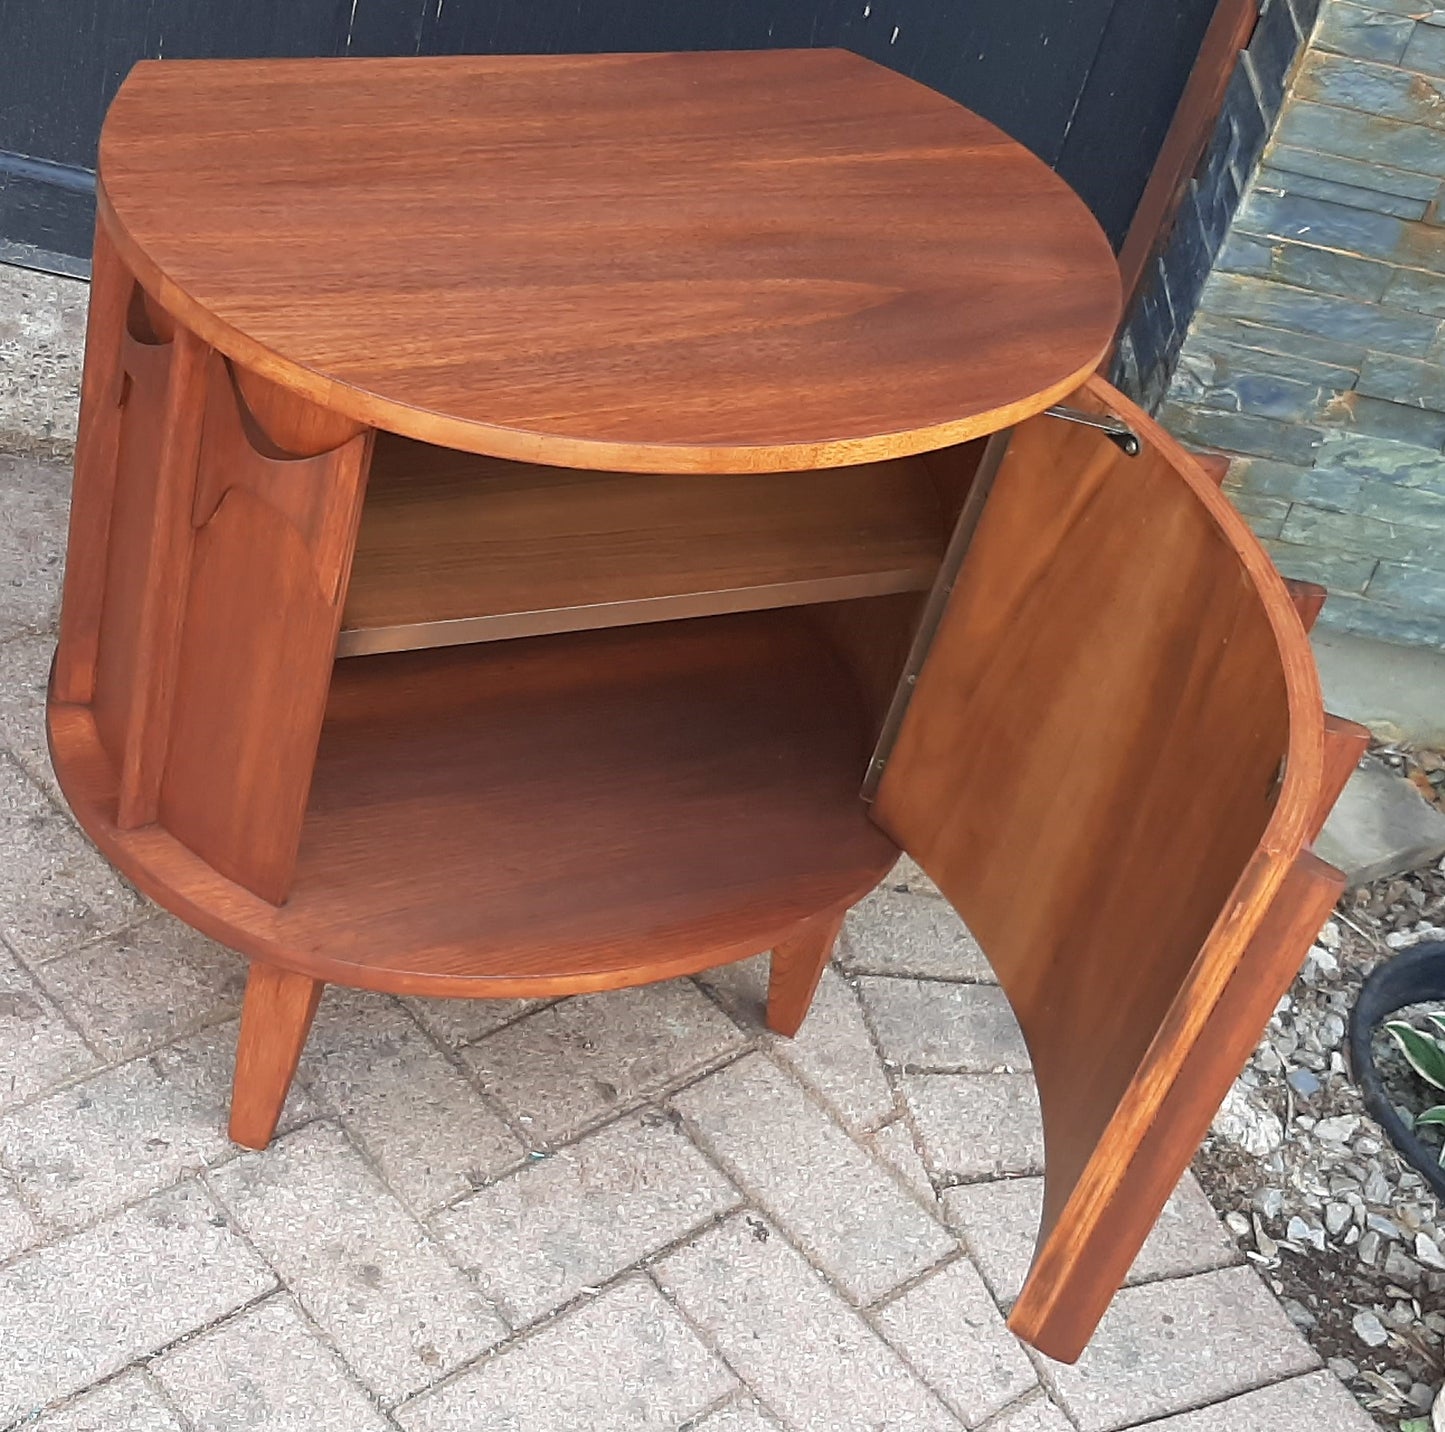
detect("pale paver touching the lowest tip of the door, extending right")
(1043, 1267), (1319, 1432)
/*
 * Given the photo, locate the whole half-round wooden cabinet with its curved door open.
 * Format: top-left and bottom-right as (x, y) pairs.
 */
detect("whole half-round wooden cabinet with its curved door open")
(49, 52), (1360, 1357)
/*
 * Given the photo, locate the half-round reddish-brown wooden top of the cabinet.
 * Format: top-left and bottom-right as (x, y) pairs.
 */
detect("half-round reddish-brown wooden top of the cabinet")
(100, 51), (1120, 473)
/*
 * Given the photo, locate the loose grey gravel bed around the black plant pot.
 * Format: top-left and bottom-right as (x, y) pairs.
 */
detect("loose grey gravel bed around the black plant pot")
(1195, 749), (1445, 1432)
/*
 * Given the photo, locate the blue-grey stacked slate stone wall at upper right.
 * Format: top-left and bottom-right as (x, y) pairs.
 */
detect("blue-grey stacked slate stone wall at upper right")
(1134, 0), (1445, 647)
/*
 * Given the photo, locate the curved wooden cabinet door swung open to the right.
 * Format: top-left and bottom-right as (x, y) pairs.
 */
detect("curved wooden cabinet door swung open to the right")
(874, 380), (1360, 1361)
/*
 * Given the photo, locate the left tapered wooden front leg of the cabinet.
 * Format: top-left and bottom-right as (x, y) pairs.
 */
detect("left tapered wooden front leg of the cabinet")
(231, 961), (325, 1149)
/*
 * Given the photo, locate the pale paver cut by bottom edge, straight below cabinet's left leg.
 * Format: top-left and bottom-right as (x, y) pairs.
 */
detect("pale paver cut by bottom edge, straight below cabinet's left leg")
(153, 1296), (392, 1432)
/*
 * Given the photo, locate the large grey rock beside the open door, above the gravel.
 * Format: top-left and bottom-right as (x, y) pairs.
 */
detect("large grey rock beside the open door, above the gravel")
(1315, 763), (1445, 886)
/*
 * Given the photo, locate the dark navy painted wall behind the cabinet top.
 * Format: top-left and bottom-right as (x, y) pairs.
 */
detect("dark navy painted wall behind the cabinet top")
(0, 0), (1214, 266)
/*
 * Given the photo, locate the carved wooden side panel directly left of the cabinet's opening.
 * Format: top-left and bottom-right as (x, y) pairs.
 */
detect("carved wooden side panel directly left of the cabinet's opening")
(160, 358), (370, 903)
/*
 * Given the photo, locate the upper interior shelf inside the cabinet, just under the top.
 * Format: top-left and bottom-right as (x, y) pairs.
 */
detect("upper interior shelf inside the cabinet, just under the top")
(337, 434), (948, 656)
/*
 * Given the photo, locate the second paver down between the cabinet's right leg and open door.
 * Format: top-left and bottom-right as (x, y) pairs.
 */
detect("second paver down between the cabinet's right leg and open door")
(858, 980), (1029, 1074)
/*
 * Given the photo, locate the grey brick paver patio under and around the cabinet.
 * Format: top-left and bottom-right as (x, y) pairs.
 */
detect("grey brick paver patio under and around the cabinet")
(0, 445), (1373, 1432)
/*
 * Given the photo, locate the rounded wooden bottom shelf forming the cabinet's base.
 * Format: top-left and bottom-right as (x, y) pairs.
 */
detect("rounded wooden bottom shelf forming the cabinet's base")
(49, 611), (897, 996)
